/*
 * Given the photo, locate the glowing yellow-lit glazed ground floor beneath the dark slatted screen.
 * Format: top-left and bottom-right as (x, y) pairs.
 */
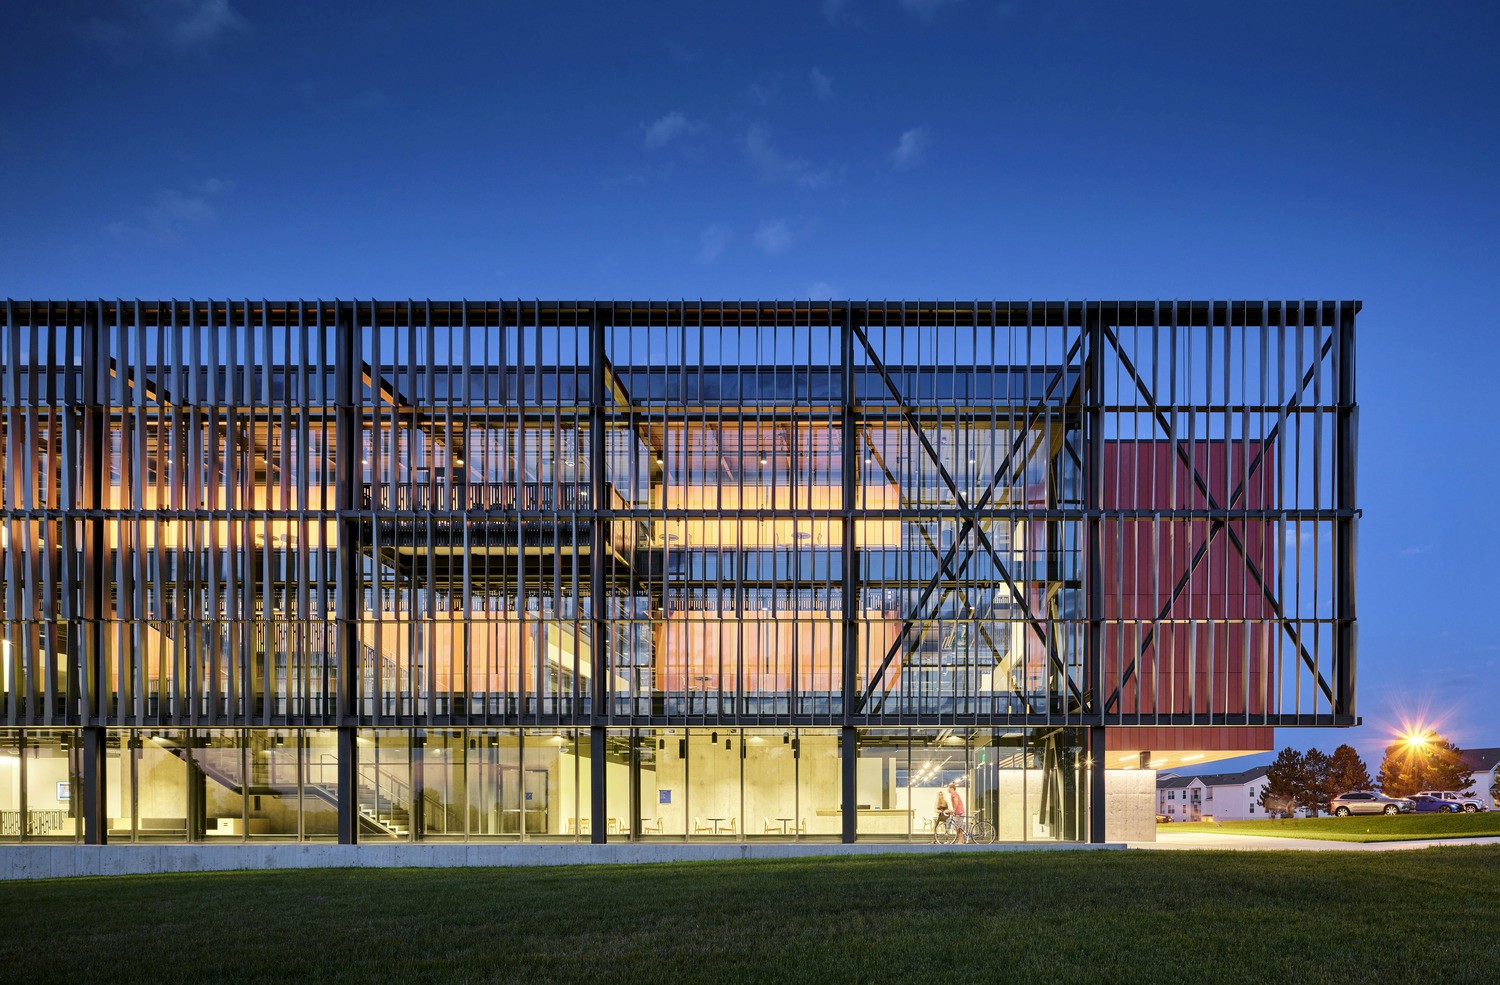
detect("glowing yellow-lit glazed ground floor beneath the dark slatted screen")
(0, 726), (1115, 844)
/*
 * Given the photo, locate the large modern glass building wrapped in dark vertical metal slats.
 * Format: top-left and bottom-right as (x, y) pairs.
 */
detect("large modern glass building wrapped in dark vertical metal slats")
(0, 300), (1359, 844)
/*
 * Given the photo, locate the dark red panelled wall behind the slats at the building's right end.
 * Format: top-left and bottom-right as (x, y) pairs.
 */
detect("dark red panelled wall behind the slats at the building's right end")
(1103, 441), (1277, 713)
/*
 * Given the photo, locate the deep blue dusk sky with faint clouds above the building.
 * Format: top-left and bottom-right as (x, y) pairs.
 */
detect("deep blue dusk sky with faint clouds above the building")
(0, 0), (1500, 768)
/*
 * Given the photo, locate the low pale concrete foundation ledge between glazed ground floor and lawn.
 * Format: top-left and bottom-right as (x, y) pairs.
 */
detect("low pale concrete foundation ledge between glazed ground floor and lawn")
(0, 843), (1125, 880)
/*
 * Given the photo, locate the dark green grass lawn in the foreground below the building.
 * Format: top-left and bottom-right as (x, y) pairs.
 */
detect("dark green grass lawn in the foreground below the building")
(0, 846), (1500, 985)
